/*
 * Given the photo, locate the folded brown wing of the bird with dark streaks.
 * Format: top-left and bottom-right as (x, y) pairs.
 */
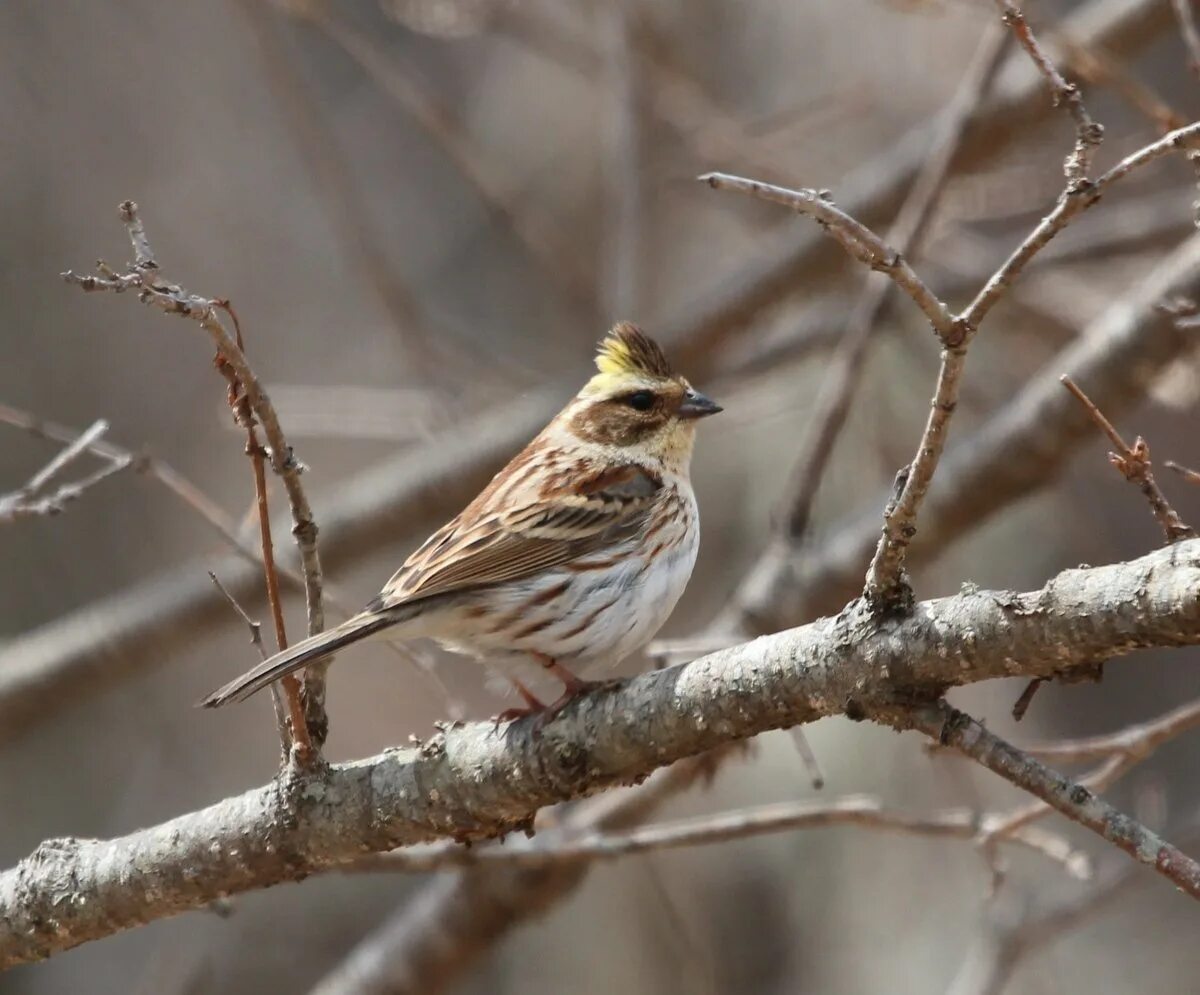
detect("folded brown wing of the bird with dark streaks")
(376, 464), (662, 607)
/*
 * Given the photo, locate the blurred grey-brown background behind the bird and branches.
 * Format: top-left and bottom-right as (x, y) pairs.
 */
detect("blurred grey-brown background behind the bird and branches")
(0, 0), (1200, 995)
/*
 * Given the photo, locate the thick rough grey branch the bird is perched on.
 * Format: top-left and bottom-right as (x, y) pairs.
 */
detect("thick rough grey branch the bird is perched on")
(0, 540), (1200, 966)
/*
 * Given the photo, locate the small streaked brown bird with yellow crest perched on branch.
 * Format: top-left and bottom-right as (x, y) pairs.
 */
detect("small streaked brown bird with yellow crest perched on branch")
(203, 323), (721, 719)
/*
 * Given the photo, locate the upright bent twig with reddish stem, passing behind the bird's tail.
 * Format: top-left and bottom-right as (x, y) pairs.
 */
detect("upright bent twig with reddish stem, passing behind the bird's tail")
(62, 200), (328, 744)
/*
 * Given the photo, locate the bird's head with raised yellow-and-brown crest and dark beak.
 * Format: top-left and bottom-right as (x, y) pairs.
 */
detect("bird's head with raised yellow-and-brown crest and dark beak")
(563, 322), (721, 472)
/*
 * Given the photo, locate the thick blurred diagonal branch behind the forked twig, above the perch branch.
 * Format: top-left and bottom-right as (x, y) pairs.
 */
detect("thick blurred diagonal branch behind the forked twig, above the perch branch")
(714, 206), (1200, 643)
